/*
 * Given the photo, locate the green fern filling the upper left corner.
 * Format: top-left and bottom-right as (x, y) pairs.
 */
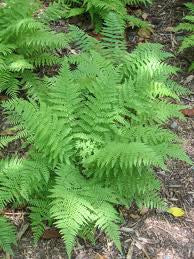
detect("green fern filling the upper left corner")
(0, 0), (67, 96)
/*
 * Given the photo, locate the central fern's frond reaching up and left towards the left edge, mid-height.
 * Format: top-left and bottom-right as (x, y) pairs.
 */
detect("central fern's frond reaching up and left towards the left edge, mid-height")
(3, 99), (72, 164)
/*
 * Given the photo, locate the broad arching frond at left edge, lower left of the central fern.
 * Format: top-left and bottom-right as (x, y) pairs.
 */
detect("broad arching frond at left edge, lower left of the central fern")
(0, 158), (50, 207)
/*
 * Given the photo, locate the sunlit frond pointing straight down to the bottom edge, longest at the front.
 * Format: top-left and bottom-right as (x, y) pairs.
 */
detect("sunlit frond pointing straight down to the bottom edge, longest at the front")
(51, 167), (93, 257)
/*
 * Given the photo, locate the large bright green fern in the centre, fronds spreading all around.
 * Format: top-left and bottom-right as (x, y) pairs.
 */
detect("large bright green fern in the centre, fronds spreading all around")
(0, 13), (190, 257)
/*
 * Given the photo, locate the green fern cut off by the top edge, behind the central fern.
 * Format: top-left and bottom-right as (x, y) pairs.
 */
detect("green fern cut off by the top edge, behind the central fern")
(43, 0), (152, 32)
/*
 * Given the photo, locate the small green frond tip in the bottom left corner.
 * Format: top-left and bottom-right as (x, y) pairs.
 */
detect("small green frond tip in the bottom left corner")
(0, 216), (16, 254)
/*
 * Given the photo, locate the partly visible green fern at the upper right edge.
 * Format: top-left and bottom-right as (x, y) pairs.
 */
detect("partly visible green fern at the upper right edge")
(175, 3), (194, 70)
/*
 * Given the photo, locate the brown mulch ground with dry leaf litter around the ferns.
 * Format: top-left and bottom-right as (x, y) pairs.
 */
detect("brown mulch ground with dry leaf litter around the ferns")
(0, 0), (194, 259)
